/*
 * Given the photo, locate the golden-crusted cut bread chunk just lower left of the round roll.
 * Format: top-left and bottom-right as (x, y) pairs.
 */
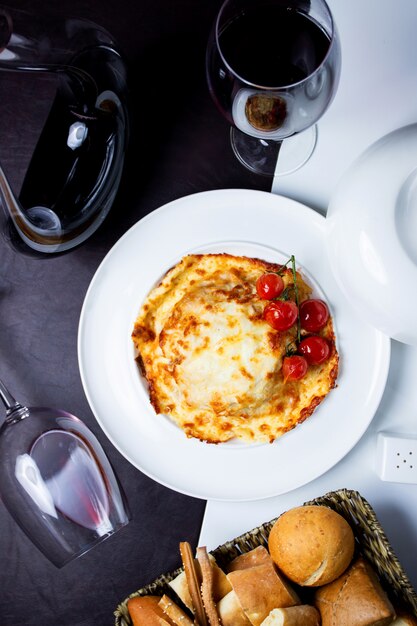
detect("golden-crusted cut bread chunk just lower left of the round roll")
(227, 560), (300, 626)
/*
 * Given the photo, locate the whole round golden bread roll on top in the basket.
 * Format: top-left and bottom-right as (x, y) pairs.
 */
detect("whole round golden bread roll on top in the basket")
(268, 505), (355, 587)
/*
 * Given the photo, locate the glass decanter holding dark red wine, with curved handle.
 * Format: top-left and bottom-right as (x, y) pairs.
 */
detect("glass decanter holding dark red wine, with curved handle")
(0, 6), (129, 253)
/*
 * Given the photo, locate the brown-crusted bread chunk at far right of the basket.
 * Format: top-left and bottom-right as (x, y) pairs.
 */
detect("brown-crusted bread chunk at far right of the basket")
(315, 558), (395, 626)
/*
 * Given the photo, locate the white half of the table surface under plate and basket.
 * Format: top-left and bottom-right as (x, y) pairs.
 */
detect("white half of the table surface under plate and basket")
(199, 0), (417, 589)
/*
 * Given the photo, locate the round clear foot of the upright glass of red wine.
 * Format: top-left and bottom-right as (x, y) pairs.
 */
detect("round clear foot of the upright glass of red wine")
(230, 125), (317, 176)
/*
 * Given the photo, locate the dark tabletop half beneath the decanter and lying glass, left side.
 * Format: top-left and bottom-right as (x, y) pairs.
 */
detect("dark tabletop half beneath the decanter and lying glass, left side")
(0, 0), (271, 626)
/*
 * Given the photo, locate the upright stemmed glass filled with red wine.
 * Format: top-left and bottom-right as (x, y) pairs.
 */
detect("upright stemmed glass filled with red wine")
(206, 0), (341, 175)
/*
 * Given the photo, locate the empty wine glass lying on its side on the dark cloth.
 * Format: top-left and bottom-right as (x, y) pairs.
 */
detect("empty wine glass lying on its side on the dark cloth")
(0, 381), (129, 567)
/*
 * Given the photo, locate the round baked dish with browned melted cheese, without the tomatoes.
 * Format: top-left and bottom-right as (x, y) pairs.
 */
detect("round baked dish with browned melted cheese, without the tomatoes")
(132, 253), (338, 443)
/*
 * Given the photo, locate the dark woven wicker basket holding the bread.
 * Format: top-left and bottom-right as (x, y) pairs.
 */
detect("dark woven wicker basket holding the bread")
(115, 489), (417, 626)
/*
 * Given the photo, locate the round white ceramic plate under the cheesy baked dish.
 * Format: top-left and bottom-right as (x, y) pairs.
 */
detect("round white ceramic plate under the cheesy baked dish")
(78, 190), (390, 501)
